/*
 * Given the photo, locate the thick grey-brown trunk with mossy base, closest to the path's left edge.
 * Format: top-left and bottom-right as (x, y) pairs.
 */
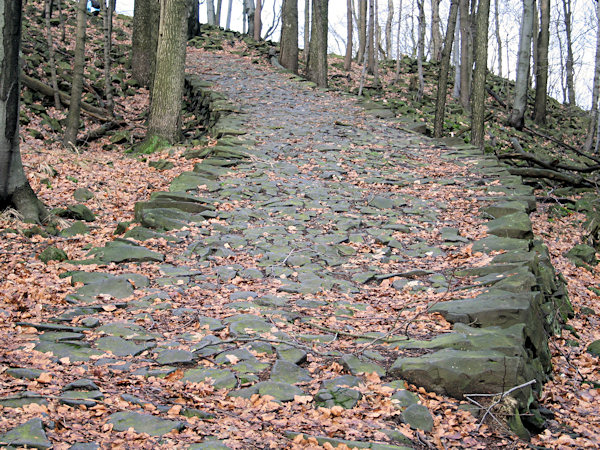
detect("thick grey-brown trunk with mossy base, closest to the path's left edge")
(147, 0), (188, 143)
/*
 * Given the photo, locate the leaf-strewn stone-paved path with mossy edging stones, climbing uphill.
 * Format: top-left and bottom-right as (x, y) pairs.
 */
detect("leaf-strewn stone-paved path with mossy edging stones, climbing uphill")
(0, 45), (563, 449)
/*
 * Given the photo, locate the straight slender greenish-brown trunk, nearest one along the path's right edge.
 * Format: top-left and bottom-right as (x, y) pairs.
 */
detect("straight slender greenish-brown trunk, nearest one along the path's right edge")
(471, 0), (490, 149)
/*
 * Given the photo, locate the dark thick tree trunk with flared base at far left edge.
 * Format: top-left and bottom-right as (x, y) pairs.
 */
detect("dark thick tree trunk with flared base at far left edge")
(0, 0), (46, 222)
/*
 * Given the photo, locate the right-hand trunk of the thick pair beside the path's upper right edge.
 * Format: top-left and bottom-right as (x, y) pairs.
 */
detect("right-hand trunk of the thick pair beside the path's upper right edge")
(307, 0), (329, 87)
